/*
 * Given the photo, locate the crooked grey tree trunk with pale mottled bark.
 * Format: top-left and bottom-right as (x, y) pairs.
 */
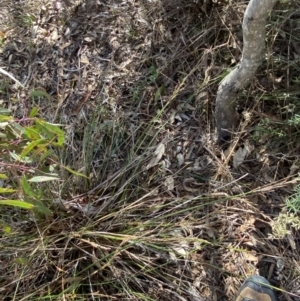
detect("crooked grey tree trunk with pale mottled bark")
(215, 0), (277, 143)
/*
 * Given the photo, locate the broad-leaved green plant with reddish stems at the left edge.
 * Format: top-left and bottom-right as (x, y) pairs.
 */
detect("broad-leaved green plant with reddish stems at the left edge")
(0, 107), (65, 215)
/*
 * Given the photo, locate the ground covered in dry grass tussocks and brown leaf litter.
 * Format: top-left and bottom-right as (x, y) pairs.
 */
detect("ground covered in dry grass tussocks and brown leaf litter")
(0, 0), (300, 301)
